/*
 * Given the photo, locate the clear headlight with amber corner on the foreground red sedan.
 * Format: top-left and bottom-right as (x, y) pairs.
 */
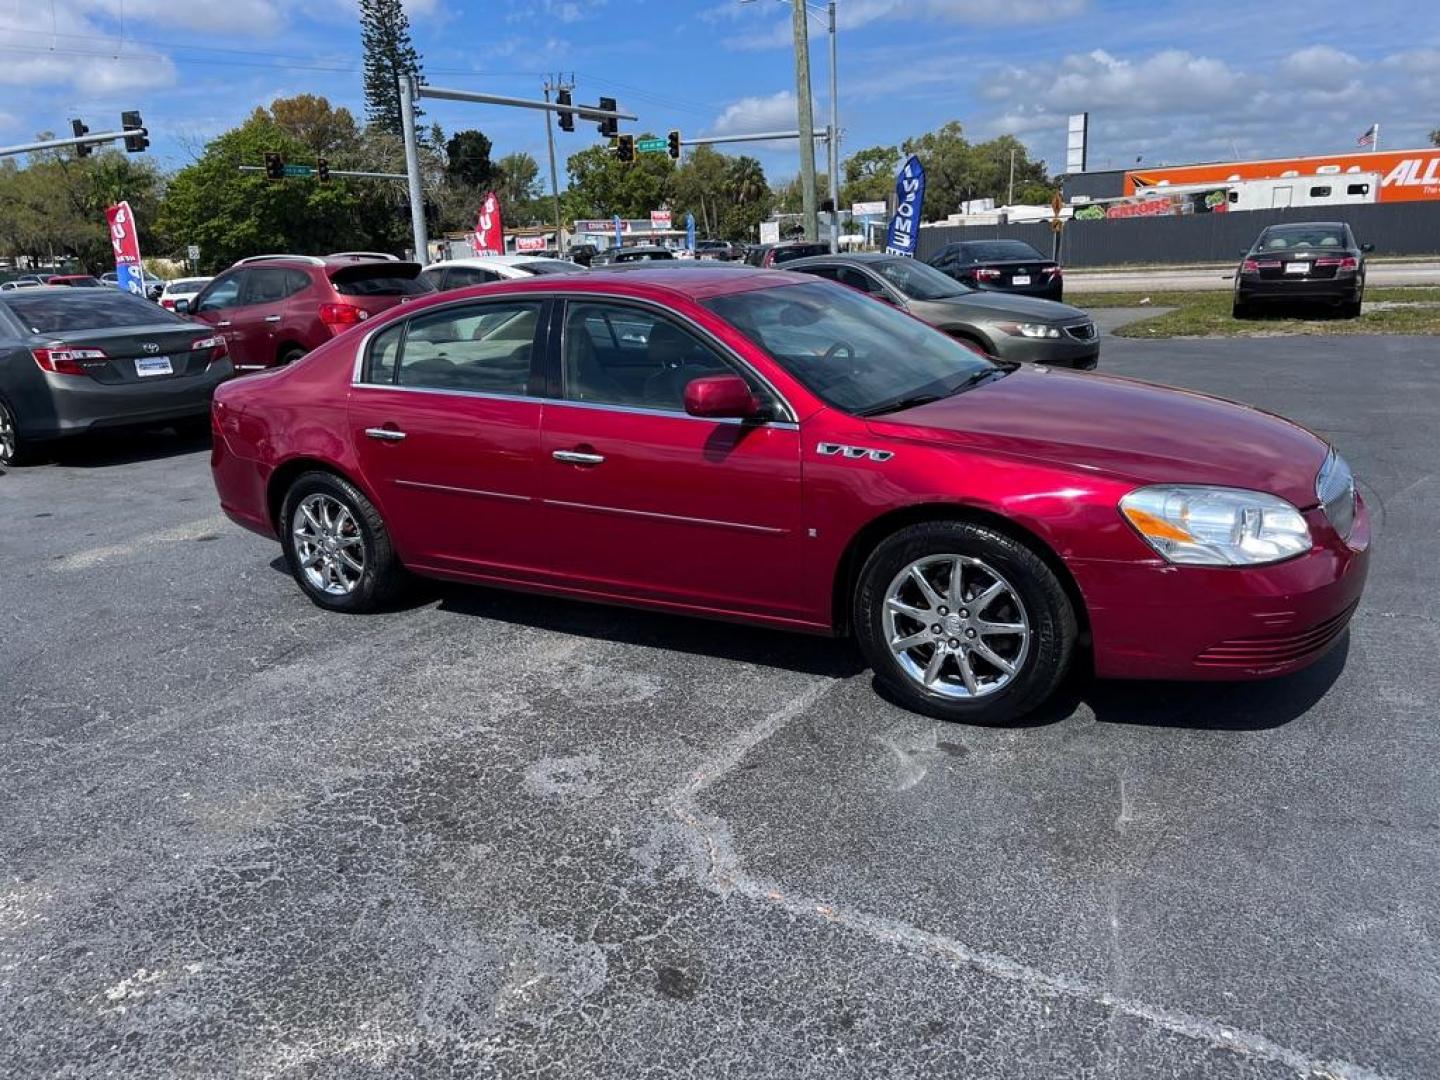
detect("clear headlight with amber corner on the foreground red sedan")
(1120, 484), (1310, 566)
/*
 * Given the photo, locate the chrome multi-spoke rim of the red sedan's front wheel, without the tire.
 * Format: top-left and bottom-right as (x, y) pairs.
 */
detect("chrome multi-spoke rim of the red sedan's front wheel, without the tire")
(883, 554), (1031, 698)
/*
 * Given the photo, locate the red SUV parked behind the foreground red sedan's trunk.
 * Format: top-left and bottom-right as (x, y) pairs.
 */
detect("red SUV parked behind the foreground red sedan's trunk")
(176, 252), (435, 372)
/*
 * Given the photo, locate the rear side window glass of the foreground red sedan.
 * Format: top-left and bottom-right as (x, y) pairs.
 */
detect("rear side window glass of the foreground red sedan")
(388, 301), (543, 396)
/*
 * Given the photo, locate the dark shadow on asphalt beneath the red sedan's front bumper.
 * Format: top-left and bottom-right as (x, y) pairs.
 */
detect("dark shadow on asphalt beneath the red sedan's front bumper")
(1076, 631), (1349, 732)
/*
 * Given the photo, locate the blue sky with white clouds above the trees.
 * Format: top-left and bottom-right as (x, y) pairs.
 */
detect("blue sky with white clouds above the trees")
(0, 0), (1440, 187)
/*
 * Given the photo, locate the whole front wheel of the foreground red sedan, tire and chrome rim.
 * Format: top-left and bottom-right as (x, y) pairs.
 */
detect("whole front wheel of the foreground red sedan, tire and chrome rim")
(855, 521), (1077, 723)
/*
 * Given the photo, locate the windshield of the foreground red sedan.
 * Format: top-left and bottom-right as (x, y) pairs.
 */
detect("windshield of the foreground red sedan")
(704, 281), (1002, 415)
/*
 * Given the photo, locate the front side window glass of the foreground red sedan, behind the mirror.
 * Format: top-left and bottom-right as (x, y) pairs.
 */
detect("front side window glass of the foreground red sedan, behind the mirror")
(564, 302), (756, 412)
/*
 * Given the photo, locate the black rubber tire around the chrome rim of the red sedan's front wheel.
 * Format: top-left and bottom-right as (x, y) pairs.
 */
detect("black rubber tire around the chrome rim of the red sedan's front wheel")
(854, 521), (1079, 724)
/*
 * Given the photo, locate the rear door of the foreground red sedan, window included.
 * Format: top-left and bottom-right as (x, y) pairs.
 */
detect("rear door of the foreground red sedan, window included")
(348, 297), (546, 577)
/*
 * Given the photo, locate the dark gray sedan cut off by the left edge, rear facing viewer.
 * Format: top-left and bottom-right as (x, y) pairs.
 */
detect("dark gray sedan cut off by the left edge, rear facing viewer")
(0, 285), (230, 465)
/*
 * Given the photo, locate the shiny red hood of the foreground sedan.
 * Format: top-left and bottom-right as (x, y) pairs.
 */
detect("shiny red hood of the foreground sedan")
(870, 366), (1329, 508)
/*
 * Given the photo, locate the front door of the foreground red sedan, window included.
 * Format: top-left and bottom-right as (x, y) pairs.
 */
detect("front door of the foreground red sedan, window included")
(537, 298), (806, 619)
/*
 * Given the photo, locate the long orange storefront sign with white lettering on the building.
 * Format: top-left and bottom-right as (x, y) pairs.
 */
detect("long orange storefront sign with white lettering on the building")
(1125, 147), (1440, 203)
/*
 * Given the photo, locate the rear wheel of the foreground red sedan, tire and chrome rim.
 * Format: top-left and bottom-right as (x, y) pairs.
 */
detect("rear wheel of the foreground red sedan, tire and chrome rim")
(281, 472), (405, 612)
